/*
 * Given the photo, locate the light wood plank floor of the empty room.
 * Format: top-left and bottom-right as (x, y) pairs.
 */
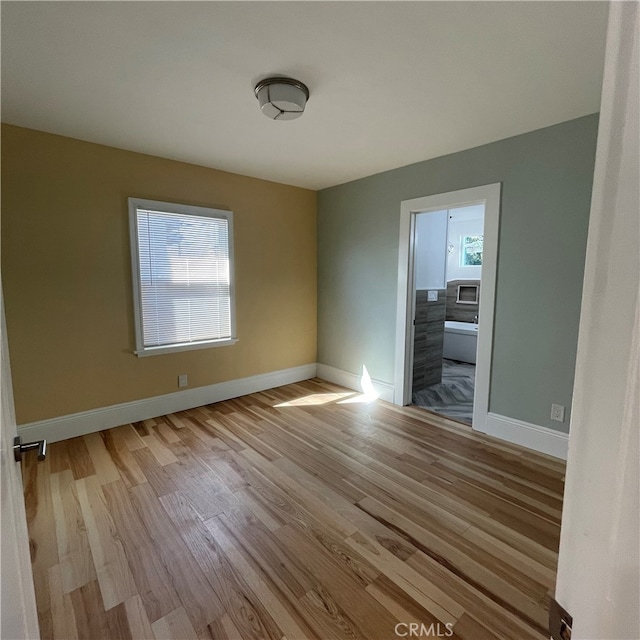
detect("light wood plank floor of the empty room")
(24, 380), (564, 640)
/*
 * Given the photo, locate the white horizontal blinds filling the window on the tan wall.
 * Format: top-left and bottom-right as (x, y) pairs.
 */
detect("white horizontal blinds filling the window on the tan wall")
(137, 208), (231, 347)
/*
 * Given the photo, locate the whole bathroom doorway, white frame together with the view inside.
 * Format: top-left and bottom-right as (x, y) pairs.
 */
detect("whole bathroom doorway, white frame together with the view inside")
(394, 183), (500, 431)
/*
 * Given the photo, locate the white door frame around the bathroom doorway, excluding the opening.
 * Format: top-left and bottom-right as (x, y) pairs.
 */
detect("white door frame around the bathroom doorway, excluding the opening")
(393, 182), (501, 432)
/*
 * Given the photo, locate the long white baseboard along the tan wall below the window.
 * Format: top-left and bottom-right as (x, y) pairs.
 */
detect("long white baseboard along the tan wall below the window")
(18, 363), (316, 442)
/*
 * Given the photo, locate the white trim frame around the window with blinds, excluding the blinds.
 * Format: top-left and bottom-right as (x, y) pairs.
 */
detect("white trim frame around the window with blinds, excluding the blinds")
(128, 198), (238, 357)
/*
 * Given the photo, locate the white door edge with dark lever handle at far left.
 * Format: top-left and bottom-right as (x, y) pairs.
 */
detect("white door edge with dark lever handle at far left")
(0, 290), (40, 640)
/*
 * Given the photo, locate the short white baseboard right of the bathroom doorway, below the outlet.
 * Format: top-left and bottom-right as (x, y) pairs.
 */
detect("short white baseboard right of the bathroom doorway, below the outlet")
(485, 413), (569, 460)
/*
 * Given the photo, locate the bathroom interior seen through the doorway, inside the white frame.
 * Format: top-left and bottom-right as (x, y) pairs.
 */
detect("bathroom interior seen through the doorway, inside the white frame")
(412, 204), (484, 425)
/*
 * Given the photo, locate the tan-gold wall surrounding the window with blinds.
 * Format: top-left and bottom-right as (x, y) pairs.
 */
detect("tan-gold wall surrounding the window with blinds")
(2, 125), (317, 424)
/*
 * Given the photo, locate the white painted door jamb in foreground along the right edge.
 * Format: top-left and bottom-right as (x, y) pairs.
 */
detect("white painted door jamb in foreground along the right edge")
(556, 2), (640, 640)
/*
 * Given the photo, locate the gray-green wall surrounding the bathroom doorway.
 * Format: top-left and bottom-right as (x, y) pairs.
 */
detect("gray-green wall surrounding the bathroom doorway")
(318, 114), (598, 431)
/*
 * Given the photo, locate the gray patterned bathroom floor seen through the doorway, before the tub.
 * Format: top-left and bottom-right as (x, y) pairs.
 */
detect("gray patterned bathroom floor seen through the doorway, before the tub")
(413, 360), (476, 424)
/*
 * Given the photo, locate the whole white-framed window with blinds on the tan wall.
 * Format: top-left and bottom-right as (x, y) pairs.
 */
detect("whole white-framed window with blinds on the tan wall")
(129, 198), (236, 356)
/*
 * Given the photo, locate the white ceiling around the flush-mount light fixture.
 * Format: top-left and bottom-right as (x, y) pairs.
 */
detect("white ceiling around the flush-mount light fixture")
(1, 1), (607, 189)
